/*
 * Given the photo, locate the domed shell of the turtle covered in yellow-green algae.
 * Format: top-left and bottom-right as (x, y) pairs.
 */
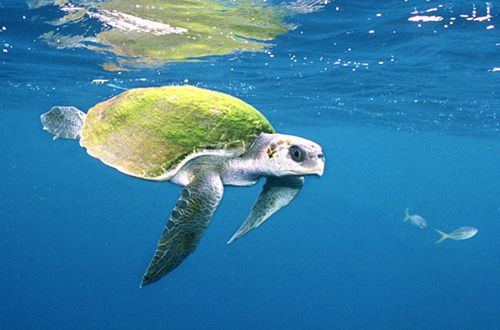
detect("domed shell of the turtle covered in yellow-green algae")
(80, 86), (274, 180)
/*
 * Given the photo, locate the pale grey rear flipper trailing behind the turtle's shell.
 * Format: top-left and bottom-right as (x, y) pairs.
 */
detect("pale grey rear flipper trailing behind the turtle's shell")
(40, 106), (86, 140)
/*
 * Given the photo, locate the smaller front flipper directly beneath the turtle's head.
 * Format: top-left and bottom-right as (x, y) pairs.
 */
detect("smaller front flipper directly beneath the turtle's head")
(227, 176), (304, 244)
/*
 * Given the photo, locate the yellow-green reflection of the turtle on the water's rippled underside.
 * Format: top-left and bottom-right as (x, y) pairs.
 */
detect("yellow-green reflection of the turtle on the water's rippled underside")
(33, 0), (288, 67)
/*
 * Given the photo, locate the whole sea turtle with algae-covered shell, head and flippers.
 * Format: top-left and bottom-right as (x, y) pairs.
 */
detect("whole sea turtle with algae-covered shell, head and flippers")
(41, 86), (324, 287)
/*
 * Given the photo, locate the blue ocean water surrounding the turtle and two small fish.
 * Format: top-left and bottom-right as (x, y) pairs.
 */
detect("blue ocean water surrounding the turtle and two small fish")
(0, 0), (500, 329)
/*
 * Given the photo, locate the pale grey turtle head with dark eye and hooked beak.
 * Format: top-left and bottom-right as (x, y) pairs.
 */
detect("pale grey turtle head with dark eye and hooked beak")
(260, 134), (325, 176)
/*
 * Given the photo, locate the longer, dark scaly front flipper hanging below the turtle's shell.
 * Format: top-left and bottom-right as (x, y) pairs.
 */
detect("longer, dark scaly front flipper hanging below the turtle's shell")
(141, 173), (224, 287)
